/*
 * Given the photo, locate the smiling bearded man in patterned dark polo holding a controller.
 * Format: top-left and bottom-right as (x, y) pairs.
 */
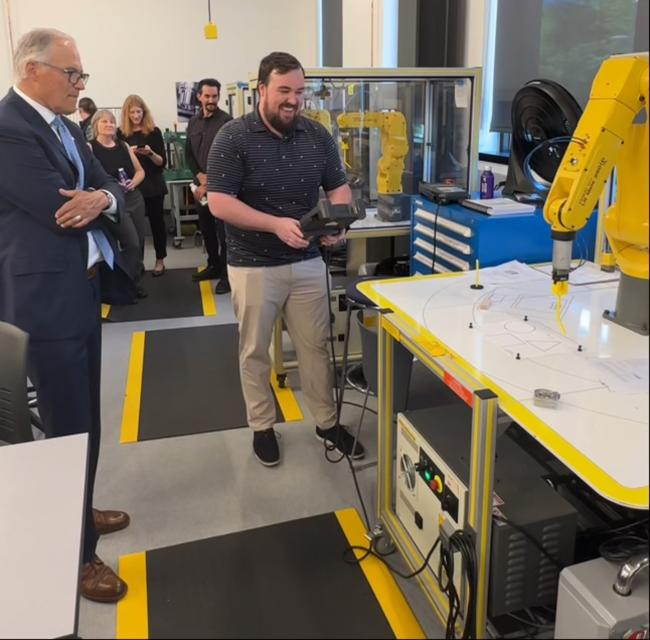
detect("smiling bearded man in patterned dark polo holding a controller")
(208, 52), (364, 466)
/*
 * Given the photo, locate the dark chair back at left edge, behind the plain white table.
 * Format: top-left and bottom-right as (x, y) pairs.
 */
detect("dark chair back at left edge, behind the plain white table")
(0, 322), (34, 444)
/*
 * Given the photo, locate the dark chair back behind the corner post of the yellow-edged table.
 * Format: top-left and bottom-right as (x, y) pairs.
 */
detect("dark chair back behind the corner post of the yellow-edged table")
(357, 309), (413, 413)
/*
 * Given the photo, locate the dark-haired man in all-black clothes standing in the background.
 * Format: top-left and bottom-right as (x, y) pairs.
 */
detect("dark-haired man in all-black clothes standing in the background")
(185, 78), (232, 293)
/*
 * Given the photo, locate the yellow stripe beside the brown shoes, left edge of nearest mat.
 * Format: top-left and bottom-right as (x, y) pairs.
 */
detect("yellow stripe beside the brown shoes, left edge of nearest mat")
(115, 552), (149, 638)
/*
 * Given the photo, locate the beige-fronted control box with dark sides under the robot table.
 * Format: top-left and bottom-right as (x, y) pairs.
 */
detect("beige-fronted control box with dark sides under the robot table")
(395, 401), (577, 617)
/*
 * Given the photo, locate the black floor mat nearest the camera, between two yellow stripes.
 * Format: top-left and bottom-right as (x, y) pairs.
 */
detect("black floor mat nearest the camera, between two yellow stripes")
(146, 513), (395, 638)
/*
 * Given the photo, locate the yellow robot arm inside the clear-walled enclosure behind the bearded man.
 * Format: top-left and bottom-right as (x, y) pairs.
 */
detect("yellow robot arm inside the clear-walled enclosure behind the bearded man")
(336, 111), (409, 194)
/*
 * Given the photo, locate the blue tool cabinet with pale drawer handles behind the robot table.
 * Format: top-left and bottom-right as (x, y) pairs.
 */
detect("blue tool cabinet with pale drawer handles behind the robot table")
(411, 197), (597, 275)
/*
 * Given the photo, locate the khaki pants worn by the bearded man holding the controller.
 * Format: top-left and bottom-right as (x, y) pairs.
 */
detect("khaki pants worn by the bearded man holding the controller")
(228, 258), (336, 431)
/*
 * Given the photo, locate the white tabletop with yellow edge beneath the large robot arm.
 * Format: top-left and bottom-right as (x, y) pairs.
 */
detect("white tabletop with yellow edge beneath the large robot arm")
(360, 263), (649, 509)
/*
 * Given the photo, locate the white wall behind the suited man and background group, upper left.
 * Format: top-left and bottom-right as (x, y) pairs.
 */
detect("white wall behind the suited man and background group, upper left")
(0, 0), (318, 129)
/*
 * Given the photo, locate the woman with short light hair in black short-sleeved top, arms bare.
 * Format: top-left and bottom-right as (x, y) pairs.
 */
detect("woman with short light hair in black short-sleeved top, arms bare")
(89, 109), (147, 298)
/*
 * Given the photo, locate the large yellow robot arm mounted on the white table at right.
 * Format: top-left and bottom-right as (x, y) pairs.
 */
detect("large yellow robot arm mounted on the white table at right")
(544, 53), (649, 333)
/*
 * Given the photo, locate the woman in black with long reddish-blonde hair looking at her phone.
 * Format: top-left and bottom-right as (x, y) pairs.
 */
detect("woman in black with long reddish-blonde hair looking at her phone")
(118, 95), (167, 278)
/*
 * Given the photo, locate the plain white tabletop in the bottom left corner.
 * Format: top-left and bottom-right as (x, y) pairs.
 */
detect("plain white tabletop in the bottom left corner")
(0, 434), (88, 638)
